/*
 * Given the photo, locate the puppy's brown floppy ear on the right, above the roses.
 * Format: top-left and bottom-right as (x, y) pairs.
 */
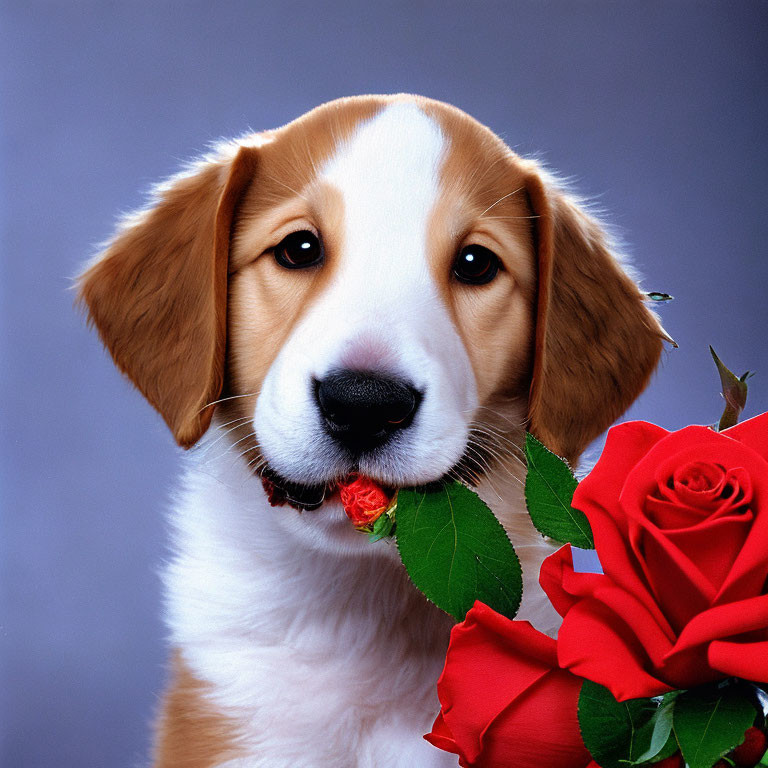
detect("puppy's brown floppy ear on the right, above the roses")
(526, 169), (666, 463)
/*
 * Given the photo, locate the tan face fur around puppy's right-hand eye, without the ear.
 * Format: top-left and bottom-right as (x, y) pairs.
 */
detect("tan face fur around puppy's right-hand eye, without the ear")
(429, 105), (536, 416)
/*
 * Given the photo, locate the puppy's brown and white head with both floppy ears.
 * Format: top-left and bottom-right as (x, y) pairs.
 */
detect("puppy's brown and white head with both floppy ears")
(80, 96), (663, 510)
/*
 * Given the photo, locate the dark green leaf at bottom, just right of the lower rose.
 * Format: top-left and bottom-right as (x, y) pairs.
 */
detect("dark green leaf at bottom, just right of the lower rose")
(579, 680), (658, 768)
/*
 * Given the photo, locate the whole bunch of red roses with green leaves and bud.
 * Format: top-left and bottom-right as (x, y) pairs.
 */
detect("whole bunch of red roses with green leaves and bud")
(352, 351), (768, 768)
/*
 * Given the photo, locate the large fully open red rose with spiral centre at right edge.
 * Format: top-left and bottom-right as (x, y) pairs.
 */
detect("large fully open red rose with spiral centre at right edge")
(541, 414), (768, 700)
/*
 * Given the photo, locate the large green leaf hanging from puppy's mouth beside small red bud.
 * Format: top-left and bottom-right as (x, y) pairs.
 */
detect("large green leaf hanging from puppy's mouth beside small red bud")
(396, 481), (523, 621)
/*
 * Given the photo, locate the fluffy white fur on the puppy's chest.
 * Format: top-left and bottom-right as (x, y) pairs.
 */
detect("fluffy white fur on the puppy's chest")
(165, 446), (457, 768)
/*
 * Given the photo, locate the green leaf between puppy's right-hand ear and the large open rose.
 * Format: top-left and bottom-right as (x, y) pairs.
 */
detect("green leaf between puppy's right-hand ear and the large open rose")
(525, 433), (595, 549)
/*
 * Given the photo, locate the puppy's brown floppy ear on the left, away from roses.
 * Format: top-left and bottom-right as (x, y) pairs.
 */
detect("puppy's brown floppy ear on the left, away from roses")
(79, 142), (257, 448)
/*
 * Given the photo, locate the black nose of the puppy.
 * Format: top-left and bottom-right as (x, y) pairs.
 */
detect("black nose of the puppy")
(316, 370), (421, 453)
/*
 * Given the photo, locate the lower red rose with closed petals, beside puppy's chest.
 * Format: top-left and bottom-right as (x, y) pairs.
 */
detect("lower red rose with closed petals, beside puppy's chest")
(424, 602), (596, 768)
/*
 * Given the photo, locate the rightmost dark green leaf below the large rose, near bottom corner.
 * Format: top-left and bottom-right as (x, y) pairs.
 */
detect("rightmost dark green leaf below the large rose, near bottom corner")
(672, 688), (757, 768)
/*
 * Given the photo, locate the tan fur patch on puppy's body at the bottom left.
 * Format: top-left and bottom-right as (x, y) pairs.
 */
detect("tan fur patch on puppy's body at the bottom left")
(153, 651), (239, 768)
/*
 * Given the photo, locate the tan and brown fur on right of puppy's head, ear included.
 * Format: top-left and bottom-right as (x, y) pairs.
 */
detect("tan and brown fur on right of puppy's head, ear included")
(427, 98), (664, 464)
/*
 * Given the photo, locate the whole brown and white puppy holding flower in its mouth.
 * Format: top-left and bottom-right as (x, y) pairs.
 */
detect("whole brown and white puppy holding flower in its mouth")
(79, 95), (663, 768)
